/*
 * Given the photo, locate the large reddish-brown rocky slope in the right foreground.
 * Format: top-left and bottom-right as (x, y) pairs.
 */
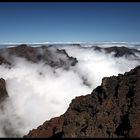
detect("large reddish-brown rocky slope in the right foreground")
(24, 66), (140, 138)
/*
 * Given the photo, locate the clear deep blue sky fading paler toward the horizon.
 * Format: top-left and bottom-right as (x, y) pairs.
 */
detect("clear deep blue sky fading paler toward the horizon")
(0, 2), (140, 43)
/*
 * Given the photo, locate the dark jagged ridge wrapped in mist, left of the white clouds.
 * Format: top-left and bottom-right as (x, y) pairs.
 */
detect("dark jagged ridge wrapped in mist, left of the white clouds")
(0, 44), (78, 68)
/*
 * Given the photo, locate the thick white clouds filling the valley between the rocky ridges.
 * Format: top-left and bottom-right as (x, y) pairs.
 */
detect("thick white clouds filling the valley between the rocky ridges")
(0, 43), (140, 137)
